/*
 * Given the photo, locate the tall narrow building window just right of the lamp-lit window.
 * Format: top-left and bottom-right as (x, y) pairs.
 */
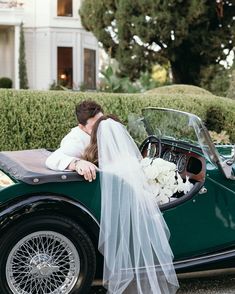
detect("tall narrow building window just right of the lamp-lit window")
(84, 49), (96, 89)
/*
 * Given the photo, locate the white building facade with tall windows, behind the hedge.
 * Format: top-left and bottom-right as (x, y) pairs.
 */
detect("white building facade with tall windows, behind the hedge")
(0, 0), (99, 90)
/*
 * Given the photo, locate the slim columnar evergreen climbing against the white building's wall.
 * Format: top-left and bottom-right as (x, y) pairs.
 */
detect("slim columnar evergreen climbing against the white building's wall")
(19, 23), (29, 89)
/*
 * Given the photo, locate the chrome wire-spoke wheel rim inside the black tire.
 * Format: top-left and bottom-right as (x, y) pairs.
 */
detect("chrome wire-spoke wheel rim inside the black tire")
(6, 231), (80, 294)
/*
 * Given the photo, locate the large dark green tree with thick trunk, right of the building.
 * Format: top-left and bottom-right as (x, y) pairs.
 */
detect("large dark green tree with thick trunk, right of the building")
(80, 0), (235, 85)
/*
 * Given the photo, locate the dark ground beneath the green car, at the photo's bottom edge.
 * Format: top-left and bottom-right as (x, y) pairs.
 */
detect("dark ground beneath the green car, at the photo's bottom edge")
(89, 275), (235, 294)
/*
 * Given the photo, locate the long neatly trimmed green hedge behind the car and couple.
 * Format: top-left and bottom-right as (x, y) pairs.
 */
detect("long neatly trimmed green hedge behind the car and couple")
(0, 89), (235, 150)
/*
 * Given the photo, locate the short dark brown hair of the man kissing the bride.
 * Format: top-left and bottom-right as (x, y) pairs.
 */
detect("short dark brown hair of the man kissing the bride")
(76, 100), (103, 126)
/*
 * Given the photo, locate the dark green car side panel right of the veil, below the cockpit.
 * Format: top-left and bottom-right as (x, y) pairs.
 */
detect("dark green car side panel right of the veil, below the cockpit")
(163, 163), (235, 260)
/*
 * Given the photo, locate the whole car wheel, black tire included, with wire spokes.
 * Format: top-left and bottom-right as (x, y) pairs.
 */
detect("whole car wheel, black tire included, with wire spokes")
(0, 215), (96, 294)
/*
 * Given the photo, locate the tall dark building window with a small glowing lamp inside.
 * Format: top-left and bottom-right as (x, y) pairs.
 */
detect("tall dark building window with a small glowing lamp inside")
(57, 47), (73, 88)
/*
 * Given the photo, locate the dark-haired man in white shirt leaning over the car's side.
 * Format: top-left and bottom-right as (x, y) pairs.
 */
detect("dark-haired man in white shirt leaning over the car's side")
(46, 100), (103, 182)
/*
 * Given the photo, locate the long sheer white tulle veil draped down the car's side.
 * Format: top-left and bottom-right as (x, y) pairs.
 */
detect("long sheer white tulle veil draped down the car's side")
(97, 118), (178, 294)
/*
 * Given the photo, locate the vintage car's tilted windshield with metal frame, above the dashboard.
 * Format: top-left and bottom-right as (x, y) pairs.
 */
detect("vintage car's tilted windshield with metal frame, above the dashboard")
(129, 108), (220, 165)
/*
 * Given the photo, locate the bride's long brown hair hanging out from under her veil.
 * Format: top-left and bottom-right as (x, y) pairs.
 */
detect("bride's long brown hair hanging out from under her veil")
(81, 115), (120, 166)
